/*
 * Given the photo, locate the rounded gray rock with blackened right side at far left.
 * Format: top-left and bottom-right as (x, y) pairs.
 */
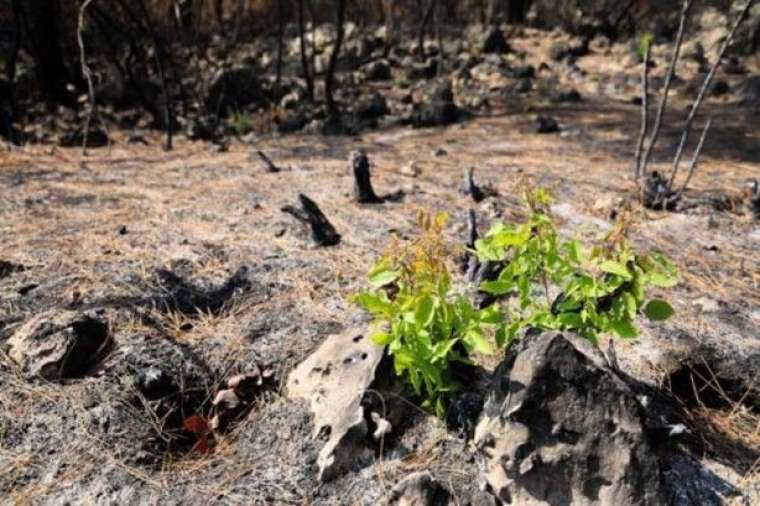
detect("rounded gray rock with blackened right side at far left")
(8, 310), (109, 380)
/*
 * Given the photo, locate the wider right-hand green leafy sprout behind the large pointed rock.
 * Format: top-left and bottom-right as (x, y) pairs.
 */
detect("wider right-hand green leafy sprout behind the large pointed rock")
(475, 190), (678, 346)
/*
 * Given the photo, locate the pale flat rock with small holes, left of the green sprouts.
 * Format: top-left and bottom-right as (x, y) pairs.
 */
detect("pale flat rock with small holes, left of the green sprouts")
(287, 329), (384, 481)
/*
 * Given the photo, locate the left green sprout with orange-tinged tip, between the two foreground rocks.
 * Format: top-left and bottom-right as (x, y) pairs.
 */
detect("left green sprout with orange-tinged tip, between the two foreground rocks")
(353, 214), (502, 416)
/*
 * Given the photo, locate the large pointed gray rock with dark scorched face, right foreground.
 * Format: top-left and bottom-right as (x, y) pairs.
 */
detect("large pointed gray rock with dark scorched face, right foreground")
(475, 332), (665, 505)
